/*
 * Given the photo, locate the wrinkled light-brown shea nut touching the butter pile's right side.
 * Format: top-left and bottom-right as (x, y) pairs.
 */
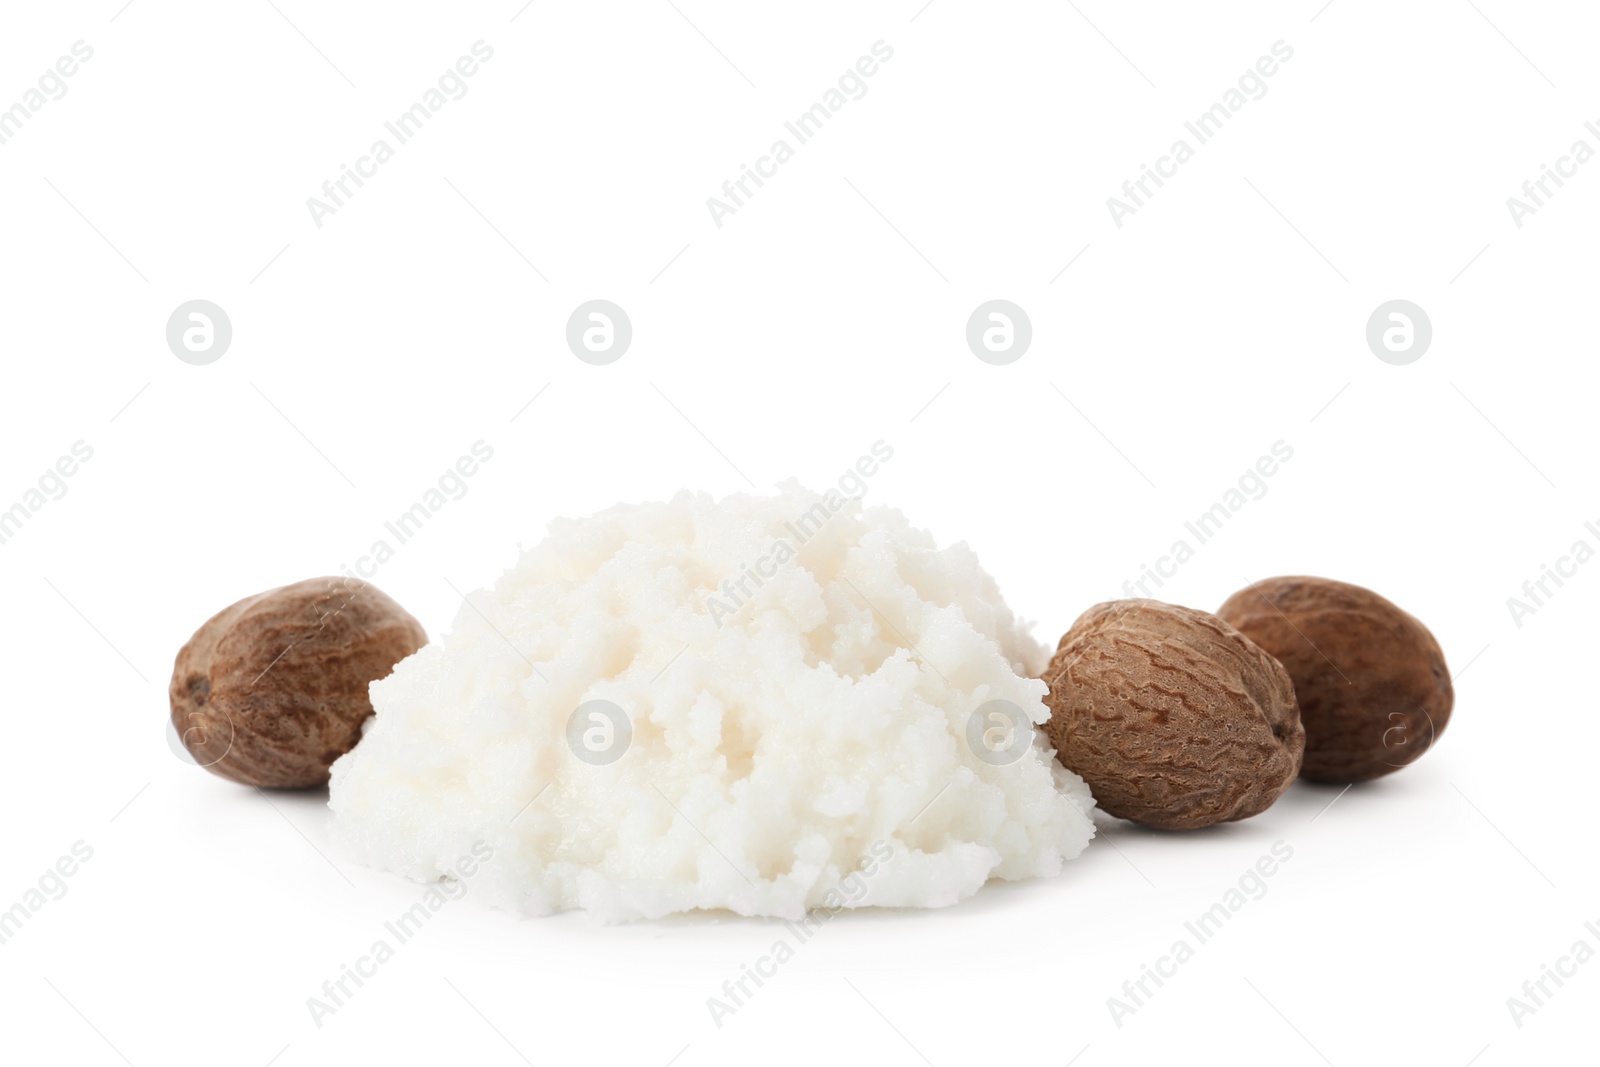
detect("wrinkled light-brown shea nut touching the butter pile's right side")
(1045, 600), (1306, 830)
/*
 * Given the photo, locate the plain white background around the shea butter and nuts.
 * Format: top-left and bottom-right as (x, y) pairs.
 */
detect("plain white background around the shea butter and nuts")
(0, 0), (1600, 1067)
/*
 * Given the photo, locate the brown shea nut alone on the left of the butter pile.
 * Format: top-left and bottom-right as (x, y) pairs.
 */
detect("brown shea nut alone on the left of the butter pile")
(170, 577), (427, 789)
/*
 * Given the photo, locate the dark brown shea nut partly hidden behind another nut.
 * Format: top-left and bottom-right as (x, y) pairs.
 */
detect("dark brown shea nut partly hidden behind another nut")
(1218, 577), (1456, 782)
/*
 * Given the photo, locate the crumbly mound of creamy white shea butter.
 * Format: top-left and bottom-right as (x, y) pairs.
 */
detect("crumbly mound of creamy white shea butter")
(330, 483), (1094, 921)
